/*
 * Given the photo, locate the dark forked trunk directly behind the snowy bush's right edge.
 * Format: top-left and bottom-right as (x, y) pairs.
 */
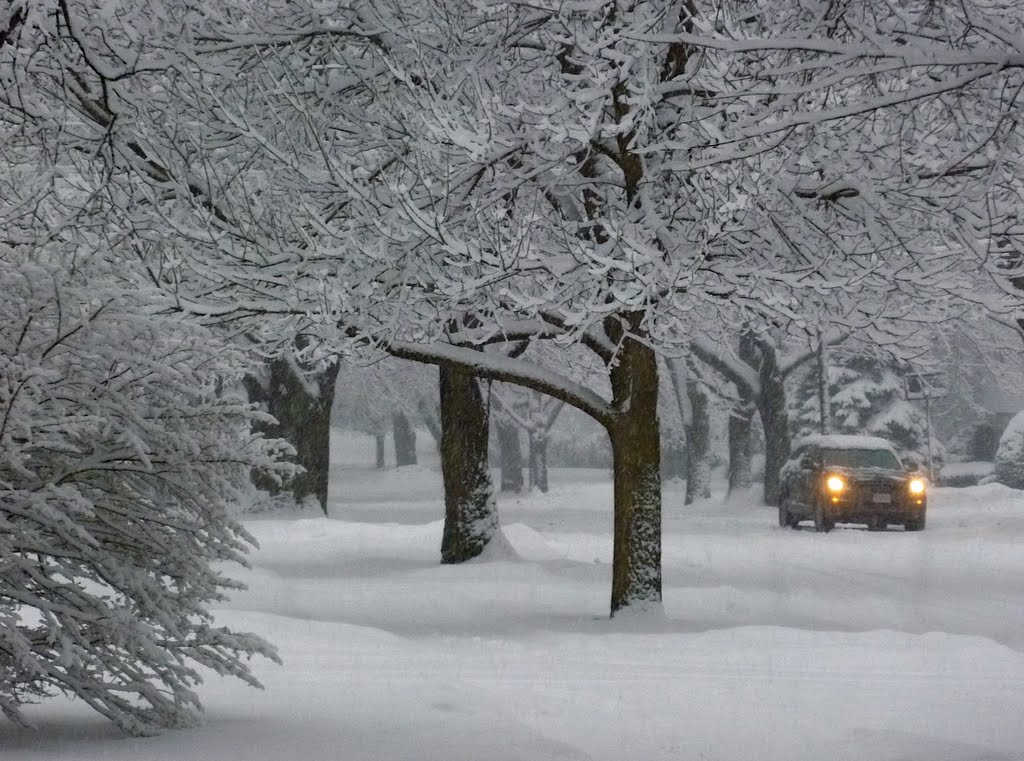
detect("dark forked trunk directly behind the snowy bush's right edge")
(245, 358), (339, 514)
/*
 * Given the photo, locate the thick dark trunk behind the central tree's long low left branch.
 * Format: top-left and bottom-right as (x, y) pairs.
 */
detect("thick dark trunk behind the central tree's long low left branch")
(439, 365), (499, 563)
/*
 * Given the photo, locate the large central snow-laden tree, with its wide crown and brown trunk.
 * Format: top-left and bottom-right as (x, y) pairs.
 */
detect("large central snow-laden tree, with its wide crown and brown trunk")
(4, 0), (1021, 610)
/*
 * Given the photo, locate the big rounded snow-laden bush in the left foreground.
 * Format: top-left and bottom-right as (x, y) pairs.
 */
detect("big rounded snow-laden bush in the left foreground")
(0, 259), (288, 733)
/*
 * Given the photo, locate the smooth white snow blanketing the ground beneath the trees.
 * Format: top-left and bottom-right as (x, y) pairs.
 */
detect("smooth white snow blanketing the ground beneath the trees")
(0, 428), (1024, 761)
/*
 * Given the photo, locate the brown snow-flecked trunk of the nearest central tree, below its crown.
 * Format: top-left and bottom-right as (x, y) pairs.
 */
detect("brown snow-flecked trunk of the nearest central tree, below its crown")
(607, 314), (662, 616)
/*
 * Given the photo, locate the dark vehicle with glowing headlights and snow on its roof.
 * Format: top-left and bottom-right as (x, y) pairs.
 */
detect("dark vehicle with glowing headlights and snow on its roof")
(778, 435), (928, 532)
